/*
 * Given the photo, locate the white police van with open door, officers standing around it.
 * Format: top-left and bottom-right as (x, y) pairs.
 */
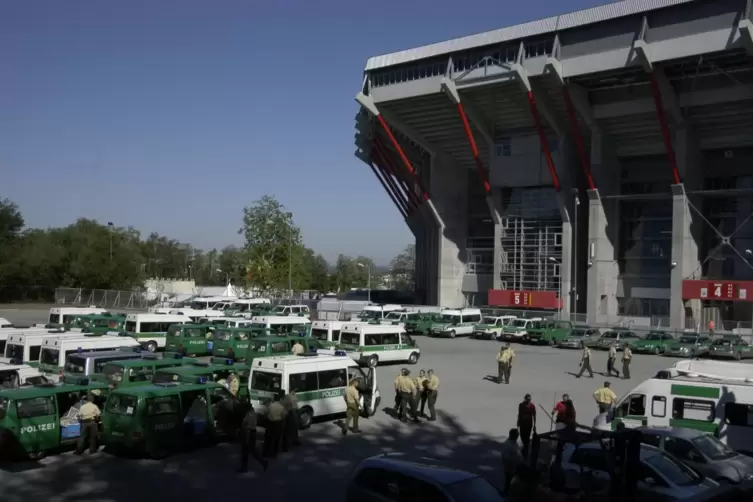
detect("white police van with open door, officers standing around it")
(248, 351), (381, 429)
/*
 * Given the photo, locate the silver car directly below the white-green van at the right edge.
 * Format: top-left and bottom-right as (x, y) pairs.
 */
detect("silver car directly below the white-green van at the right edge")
(638, 427), (753, 484)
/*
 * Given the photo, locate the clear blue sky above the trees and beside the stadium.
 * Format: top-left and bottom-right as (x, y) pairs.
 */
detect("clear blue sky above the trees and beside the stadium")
(0, 0), (604, 263)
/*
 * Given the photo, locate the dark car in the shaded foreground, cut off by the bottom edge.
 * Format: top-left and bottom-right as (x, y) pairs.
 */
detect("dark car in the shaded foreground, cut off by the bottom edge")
(345, 453), (505, 502)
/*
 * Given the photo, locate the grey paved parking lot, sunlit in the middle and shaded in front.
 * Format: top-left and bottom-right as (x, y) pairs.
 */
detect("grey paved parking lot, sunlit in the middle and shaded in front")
(0, 310), (748, 502)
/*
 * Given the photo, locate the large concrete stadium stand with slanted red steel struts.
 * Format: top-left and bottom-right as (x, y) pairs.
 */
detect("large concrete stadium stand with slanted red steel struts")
(356, 0), (753, 327)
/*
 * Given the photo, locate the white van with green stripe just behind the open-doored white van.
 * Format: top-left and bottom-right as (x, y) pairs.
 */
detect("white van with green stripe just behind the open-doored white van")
(337, 323), (421, 367)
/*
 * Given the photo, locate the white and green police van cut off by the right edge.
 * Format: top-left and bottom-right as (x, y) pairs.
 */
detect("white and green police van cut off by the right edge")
(607, 359), (753, 455)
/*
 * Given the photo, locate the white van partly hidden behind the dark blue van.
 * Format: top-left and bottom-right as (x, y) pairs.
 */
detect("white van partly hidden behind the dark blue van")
(39, 336), (141, 382)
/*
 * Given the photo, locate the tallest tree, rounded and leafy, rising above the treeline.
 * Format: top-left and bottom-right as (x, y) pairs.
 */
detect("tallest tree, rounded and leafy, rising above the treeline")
(238, 195), (303, 291)
